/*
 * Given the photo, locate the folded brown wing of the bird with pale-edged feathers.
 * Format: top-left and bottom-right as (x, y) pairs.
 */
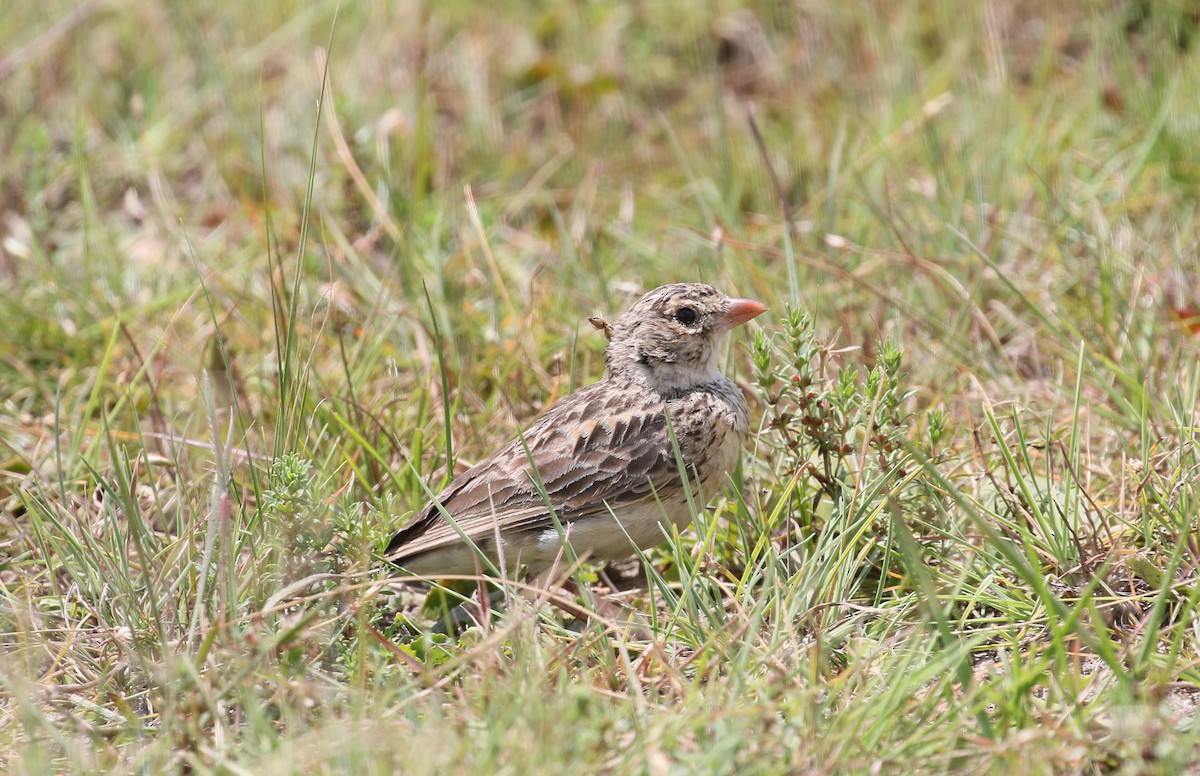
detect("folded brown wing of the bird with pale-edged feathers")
(385, 381), (682, 565)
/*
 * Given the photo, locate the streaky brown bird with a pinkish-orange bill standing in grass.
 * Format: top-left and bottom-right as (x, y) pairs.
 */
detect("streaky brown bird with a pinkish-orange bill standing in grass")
(383, 283), (767, 578)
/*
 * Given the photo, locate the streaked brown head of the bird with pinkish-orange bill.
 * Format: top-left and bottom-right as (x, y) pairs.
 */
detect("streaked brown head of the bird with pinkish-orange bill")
(605, 283), (767, 389)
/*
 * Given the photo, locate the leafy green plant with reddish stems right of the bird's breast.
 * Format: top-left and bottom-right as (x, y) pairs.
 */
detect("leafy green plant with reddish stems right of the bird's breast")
(752, 307), (944, 603)
